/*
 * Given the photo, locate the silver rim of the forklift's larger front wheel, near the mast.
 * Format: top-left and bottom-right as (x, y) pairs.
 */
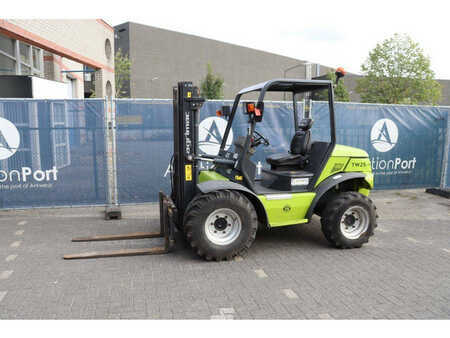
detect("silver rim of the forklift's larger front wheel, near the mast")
(205, 208), (242, 245)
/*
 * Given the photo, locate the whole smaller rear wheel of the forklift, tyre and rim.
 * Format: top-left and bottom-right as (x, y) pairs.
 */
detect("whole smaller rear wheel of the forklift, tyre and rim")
(321, 191), (378, 249)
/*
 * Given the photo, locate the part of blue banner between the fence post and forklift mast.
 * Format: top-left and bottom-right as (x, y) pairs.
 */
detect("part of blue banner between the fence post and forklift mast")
(115, 99), (173, 204)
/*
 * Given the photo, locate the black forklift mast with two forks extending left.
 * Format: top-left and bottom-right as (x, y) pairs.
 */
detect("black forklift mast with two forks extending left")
(64, 82), (205, 259)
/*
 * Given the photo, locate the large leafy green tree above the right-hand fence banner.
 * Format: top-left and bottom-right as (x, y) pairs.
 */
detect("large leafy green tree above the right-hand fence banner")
(356, 34), (441, 105)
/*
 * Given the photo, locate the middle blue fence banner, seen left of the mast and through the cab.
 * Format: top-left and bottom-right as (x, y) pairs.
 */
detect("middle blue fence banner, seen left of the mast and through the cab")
(115, 99), (303, 204)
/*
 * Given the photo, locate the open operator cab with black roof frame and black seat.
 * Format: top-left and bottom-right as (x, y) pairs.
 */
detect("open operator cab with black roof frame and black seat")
(216, 79), (335, 195)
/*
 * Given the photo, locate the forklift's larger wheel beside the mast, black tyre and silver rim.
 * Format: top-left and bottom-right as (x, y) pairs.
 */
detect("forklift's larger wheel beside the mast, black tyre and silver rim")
(183, 190), (258, 261)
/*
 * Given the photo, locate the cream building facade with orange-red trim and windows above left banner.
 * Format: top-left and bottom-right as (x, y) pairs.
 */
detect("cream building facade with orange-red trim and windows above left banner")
(0, 19), (115, 98)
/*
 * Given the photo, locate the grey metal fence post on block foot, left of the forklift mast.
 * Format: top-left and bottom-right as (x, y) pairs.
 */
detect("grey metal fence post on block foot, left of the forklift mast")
(105, 98), (122, 220)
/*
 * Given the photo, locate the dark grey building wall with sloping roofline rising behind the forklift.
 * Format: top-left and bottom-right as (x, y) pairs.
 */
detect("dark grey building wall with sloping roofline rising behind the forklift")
(115, 23), (334, 99)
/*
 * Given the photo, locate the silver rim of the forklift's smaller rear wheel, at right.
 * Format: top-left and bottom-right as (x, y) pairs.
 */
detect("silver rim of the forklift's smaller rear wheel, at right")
(340, 205), (370, 239)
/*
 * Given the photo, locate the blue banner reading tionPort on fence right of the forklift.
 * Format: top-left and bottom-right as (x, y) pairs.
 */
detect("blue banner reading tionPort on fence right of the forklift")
(312, 102), (448, 189)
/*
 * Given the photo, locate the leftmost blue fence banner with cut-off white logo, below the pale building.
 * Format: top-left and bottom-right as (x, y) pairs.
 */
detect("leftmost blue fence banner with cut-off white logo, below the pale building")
(0, 99), (106, 208)
